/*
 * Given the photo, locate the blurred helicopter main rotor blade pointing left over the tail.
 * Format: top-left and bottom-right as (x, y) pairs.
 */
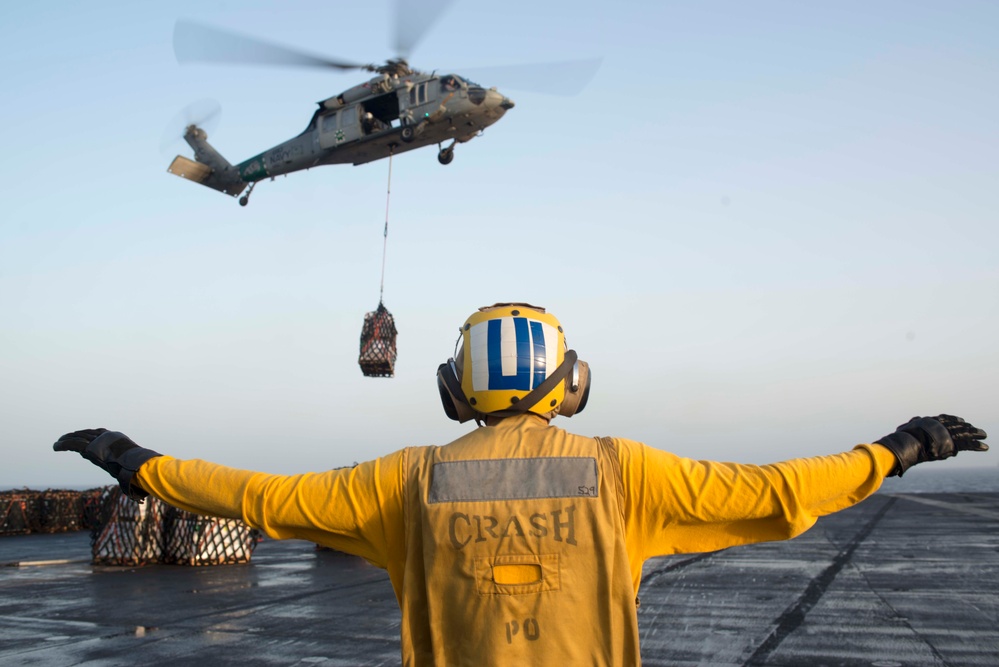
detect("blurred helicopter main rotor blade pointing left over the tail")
(173, 21), (374, 71)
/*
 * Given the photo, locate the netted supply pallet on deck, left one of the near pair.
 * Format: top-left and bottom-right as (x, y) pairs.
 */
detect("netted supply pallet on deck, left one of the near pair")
(90, 486), (166, 565)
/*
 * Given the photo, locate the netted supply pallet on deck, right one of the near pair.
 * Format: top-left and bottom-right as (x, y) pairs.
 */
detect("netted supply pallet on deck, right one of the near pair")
(163, 507), (257, 565)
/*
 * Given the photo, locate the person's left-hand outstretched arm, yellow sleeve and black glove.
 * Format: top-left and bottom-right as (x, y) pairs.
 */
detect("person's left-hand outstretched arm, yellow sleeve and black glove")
(53, 429), (405, 567)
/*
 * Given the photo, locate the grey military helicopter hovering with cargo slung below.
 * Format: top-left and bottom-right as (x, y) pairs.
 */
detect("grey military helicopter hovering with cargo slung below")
(168, 3), (599, 206)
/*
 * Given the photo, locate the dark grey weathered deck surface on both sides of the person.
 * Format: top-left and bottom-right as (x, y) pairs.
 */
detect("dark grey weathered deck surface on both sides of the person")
(0, 493), (999, 667)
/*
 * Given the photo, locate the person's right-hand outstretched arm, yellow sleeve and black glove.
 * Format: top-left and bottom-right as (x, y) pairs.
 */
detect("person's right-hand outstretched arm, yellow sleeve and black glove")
(618, 415), (988, 559)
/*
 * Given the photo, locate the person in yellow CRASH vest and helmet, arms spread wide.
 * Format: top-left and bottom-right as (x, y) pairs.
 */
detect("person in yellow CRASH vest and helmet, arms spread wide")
(53, 303), (988, 666)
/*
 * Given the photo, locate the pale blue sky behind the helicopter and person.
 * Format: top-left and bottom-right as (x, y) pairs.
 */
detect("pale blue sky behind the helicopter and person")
(0, 0), (999, 488)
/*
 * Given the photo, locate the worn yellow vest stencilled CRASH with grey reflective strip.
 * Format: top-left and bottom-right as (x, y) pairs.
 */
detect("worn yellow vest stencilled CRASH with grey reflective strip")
(400, 419), (640, 667)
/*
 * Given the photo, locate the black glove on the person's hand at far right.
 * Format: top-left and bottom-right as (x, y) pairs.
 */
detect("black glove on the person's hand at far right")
(874, 415), (989, 477)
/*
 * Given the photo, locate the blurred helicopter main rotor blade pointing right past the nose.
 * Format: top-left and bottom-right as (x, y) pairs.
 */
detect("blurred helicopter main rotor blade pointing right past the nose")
(454, 58), (603, 97)
